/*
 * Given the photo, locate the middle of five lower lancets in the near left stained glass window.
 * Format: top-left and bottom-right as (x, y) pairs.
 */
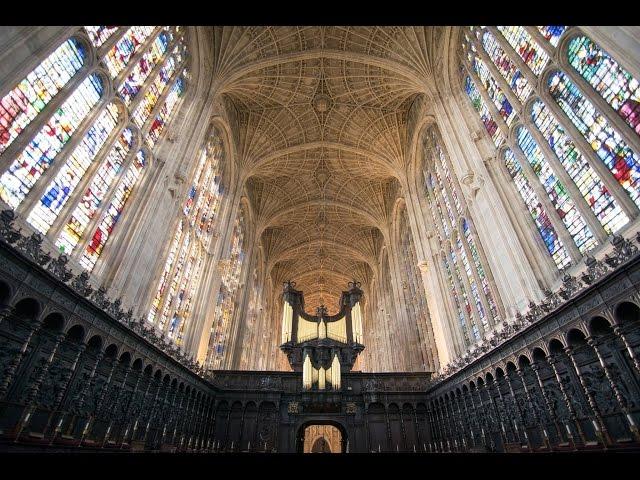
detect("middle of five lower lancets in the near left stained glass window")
(27, 103), (119, 233)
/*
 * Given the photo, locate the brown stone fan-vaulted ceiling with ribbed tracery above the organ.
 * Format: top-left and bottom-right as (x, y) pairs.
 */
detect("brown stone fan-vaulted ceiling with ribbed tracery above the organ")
(213, 27), (438, 312)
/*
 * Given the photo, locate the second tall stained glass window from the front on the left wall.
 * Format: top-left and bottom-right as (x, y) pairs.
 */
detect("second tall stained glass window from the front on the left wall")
(147, 127), (224, 345)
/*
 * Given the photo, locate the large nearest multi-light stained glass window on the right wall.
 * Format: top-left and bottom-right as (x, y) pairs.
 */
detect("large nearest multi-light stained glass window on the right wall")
(461, 26), (640, 268)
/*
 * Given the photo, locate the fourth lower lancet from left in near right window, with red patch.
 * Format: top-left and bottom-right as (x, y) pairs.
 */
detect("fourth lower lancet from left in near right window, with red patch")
(548, 72), (640, 206)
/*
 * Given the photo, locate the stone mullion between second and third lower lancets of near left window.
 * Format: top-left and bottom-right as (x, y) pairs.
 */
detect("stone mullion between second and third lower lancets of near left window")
(15, 77), (118, 217)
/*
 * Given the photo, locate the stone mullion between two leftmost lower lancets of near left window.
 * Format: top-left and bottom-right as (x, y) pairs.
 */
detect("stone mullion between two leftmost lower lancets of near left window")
(0, 49), (96, 173)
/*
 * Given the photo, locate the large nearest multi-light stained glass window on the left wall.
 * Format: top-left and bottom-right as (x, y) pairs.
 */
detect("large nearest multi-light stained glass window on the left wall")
(0, 26), (187, 270)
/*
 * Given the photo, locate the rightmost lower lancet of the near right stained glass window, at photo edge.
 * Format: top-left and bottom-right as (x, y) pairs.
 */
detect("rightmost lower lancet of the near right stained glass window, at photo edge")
(567, 36), (640, 135)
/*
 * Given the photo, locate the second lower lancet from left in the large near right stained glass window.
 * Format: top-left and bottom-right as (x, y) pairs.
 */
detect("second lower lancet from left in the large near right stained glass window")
(516, 127), (596, 253)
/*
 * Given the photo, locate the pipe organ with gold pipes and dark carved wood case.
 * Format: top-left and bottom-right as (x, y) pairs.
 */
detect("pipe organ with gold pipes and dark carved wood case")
(280, 281), (364, 391)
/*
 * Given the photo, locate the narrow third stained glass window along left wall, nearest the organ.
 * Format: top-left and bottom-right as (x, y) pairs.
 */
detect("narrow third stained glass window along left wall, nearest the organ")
(207, 204), (245, 369)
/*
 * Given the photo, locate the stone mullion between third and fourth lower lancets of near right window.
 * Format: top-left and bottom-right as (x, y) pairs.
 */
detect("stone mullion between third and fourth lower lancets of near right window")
(527, 89), (640, 220)
